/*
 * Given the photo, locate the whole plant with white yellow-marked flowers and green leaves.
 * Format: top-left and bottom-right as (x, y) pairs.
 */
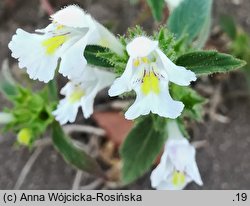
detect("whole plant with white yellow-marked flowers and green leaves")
(0, 0), (245, 189)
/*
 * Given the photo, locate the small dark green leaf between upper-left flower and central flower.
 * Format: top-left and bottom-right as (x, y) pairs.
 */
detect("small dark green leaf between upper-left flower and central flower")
(84, 45), (112, 67)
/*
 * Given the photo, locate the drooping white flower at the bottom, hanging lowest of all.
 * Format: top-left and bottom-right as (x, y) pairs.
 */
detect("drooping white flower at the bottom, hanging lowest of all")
(150, 121), (203, 190)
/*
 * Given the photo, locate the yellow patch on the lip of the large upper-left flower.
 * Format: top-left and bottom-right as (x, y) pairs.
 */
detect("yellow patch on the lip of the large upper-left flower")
(42, 35), (68, 55)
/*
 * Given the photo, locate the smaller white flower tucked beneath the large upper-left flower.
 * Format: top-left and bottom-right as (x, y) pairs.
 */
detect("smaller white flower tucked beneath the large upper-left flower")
(53, 66), (115, 125)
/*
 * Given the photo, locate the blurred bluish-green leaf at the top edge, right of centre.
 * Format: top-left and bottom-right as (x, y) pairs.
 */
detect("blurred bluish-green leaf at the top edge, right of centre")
(167, 0), (212, 43)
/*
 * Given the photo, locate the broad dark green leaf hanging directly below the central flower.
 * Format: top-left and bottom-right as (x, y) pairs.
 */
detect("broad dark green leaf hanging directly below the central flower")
(120, 115), (167, 184)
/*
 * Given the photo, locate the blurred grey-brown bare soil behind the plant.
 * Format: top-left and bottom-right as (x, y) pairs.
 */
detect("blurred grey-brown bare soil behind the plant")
(0, 0), (250, 189)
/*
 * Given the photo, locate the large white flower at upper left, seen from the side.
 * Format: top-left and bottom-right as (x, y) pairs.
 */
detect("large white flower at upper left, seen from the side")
(9, 5), (123, 83)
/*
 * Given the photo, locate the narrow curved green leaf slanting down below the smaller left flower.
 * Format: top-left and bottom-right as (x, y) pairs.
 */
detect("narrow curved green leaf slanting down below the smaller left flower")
(52, 122), (103, 176)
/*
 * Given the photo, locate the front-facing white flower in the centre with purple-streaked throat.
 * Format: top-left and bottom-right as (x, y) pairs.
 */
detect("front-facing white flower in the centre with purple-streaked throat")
(109, 36), (196, 119)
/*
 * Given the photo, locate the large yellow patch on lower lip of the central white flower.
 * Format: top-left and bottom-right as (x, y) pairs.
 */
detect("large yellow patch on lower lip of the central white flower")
(141, 72), (160, 95)
